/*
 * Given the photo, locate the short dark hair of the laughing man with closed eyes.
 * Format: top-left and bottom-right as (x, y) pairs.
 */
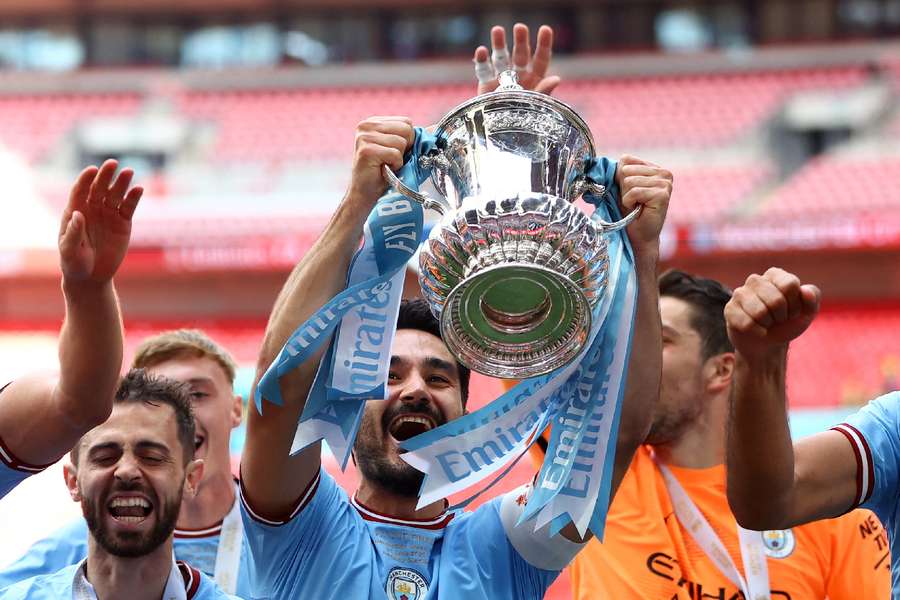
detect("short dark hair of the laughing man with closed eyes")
(71, 369), (194, 465)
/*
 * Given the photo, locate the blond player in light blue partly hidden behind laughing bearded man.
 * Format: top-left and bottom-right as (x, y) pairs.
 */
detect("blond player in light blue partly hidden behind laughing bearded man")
(0, 329), (250, 596)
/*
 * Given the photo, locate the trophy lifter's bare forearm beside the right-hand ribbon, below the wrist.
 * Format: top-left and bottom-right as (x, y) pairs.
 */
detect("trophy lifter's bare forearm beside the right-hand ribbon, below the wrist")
(610, 250), (662, 492)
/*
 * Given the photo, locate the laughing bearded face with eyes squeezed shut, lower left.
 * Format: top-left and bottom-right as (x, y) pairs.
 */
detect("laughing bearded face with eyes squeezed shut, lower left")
(66, 402), (202, 557)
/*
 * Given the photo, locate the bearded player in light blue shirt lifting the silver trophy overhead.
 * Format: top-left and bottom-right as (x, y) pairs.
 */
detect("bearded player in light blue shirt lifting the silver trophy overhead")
(241, 24), (672, 600)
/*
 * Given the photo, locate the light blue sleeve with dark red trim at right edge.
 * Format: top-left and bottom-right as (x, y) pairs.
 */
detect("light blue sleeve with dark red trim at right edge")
(833, 392), (900, 520)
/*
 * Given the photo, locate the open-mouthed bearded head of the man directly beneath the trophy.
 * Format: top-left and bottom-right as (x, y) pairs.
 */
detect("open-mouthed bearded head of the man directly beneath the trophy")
(353, 329), (464, 496)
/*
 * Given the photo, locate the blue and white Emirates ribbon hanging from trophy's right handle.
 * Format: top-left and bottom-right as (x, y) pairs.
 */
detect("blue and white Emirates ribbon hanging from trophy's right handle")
(401, 158), (637, 538)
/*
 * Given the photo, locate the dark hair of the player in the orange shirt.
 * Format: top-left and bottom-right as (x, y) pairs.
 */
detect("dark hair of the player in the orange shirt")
(659, 269), (734, 360)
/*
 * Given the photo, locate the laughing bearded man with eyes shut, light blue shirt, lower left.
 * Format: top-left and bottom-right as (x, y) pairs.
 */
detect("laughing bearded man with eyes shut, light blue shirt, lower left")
(0, 369), (232, 600)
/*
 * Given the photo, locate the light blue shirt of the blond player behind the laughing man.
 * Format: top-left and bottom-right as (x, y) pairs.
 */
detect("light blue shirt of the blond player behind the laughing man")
(0, 510), (250, 598)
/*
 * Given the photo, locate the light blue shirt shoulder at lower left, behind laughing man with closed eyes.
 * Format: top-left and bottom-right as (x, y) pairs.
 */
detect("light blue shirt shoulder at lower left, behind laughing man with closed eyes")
(0, 518), (88, 589)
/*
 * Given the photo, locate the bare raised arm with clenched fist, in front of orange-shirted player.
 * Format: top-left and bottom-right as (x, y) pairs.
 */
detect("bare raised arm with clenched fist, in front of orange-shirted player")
(725, 268), (857, 530)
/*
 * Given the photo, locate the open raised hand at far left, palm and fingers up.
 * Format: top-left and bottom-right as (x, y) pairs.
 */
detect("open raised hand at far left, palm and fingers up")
(59, 160), (144, 283)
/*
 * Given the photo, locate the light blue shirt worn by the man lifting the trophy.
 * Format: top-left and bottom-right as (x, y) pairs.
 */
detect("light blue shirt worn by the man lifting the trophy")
(242, 471), (582, 600)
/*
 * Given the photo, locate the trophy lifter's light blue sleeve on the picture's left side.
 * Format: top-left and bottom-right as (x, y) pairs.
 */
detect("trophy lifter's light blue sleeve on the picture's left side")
(241, 469), (347, 598)
